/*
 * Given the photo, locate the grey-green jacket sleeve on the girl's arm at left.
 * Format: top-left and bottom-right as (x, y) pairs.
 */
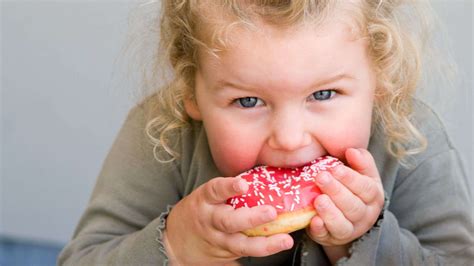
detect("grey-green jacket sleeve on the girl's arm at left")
(58, 103), (182, 265)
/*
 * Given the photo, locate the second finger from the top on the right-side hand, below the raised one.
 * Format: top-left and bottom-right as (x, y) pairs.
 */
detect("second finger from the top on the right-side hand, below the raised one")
(330, 165), (383, 204)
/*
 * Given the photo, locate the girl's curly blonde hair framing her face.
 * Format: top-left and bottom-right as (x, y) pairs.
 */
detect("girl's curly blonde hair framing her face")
(126, 0), (440, 163)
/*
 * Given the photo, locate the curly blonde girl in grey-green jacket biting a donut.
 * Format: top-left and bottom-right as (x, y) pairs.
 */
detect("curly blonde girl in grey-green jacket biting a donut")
(59, 0), (473, 265)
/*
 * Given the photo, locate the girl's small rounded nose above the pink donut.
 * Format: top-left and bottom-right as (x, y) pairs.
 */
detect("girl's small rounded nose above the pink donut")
(268, 108), (311, 151)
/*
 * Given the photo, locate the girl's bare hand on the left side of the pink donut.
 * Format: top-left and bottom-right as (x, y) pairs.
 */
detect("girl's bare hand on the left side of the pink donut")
(165, 177), (293, 265)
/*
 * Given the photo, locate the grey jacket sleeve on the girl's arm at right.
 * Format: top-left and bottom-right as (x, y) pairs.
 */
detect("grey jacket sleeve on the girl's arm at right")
(338, 104), (474, 265)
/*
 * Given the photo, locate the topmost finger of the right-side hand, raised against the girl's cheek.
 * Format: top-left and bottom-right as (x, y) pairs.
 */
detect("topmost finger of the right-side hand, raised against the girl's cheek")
(345, 148), (380, 179)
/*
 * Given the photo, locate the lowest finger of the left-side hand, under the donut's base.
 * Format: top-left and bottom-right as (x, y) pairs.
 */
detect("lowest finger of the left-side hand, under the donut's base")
(226, 233), (293, 257)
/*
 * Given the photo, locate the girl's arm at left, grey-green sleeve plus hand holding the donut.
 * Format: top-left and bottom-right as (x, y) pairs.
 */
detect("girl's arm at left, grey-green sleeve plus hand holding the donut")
(58, 103), (293, 265)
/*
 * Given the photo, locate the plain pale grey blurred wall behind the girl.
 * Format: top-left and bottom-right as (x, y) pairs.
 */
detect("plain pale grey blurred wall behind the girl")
(0, 0), (473, 243)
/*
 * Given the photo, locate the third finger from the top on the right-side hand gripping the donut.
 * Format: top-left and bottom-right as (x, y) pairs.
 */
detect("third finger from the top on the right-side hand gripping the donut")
(316, 172), (367, 222)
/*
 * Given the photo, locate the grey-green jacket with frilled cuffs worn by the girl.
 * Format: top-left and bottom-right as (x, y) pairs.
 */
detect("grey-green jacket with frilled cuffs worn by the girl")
(58, 102), (474, 265)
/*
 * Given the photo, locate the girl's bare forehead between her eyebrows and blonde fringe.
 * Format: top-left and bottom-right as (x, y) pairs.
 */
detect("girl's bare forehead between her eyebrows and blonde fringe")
(196, 20), (369, 93)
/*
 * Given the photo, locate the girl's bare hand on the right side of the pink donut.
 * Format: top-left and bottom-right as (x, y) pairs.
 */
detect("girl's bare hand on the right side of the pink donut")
(307, 149), (384, 250)
